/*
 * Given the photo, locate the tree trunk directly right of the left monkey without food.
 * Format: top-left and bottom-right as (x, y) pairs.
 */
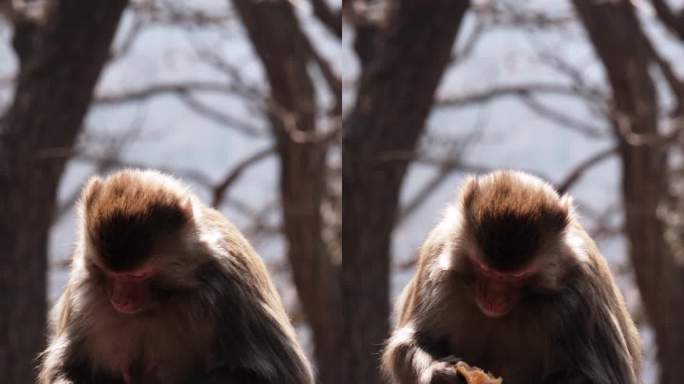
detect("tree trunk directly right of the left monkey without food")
(233, 0), (347, 384)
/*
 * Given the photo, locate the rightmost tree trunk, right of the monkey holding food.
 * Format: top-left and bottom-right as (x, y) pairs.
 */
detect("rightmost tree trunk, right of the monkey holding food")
(574, 0), (684, 384)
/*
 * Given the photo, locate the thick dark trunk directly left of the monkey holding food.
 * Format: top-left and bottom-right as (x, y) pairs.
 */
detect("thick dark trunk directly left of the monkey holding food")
(342, 0), (469, 384)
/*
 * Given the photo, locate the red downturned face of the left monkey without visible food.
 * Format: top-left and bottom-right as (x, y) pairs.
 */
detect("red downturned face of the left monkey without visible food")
(107, 267), (155, 314)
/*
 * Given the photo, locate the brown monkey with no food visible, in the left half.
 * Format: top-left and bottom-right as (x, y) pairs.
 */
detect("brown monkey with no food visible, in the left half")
(39, 170), (313, 384)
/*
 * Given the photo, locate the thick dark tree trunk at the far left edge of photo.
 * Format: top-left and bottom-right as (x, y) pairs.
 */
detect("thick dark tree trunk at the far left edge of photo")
(0, 0), (126, 384)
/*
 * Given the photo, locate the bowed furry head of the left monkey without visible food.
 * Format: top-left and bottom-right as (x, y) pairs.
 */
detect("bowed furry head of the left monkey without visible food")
(81, 170), (197, 314)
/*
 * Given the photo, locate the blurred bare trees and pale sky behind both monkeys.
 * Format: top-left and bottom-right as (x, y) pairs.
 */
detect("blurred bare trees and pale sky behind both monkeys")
(0, 0), (684, 384)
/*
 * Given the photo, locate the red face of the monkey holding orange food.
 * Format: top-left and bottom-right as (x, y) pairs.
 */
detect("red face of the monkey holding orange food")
(470, 256), (537, 318)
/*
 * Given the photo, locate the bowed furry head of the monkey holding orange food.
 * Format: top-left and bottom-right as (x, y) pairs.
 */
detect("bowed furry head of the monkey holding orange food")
(457, 171), (575, 318)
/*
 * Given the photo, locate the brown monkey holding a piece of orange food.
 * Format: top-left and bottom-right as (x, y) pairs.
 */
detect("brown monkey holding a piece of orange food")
(383, 171), (640, 384)
